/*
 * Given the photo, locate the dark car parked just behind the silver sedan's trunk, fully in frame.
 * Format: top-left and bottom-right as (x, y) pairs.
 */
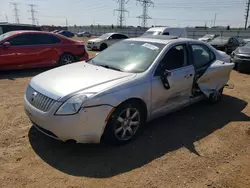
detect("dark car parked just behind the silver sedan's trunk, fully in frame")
(209, 36), (240, 54)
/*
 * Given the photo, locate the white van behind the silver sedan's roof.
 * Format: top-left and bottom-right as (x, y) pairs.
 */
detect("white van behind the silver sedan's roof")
(143, 27), (188, 38)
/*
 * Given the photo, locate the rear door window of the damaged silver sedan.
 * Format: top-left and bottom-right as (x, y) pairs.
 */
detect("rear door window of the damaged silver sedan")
(191, 44), (215, 69)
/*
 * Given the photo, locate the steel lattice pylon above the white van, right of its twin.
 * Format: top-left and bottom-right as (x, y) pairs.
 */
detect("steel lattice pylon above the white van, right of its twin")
(136, 0), (154, 28)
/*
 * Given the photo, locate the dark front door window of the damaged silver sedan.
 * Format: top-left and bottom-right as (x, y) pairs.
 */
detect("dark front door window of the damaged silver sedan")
(156, 44), (187, 75)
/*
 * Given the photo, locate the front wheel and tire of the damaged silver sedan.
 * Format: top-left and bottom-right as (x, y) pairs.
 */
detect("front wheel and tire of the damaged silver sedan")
(103, 102), (146, 145)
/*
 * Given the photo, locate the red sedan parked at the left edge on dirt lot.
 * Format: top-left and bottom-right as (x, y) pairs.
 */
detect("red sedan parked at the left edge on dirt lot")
(0, 31), (89, 70)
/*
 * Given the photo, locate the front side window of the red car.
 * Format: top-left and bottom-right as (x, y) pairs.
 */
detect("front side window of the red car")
(8, 34), (34, 46)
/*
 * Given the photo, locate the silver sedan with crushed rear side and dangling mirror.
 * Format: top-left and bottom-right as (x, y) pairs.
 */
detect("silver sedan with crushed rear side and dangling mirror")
(24, 38), (234, 144)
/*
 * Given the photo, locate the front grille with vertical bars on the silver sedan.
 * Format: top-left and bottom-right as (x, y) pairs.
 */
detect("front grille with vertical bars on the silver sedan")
(26, 85), (56, 112)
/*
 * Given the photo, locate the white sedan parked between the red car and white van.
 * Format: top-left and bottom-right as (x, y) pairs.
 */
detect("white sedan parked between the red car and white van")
(87, 33), (128, 50)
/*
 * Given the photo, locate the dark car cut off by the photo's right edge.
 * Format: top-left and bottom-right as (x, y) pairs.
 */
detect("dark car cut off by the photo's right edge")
(231, 42), (250, 72)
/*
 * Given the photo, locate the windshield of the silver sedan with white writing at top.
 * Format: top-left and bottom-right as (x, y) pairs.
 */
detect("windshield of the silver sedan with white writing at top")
(90, 40), (165, 73)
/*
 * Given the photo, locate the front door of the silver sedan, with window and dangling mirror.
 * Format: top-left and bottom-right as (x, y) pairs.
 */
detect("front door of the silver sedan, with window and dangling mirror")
(152, 44), (195, 116)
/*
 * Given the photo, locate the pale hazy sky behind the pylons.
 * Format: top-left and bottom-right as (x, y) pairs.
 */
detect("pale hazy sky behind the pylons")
(0, 0), (246, 27)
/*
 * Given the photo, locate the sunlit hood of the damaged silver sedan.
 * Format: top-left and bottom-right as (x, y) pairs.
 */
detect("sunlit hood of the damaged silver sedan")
(30, 62), (136, 100)
